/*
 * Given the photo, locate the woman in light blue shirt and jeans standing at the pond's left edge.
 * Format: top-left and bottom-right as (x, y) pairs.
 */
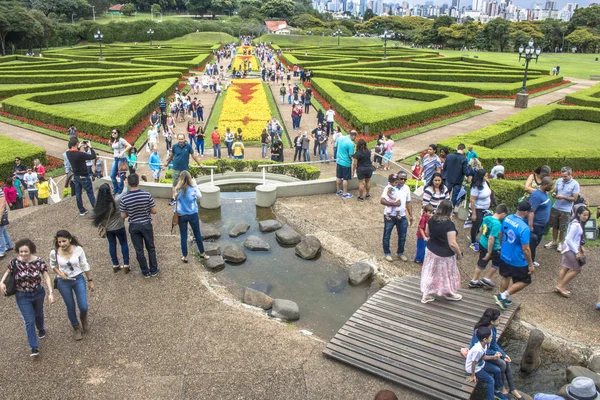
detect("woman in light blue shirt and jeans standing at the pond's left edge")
(173, 171), (210, 263)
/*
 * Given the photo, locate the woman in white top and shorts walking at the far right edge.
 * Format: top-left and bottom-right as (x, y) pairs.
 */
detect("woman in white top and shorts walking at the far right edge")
(556, 206), (590, 297)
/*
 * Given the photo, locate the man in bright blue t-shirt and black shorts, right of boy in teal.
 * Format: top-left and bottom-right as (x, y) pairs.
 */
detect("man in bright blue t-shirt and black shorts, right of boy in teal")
(494, 201), (535, 310)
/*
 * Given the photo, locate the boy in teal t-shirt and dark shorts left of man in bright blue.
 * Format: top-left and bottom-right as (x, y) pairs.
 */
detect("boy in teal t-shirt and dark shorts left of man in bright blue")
(469, 204), (508, 289)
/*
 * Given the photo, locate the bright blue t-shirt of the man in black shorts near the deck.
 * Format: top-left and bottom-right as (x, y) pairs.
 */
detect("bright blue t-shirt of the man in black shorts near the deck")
(500, 214), (530, 267)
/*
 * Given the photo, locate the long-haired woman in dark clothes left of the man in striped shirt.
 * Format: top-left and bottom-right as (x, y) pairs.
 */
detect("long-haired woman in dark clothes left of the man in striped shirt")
(92, 183), (131, 274)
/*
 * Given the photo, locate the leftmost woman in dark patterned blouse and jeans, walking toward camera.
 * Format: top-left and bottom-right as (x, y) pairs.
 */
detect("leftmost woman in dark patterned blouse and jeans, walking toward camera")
(0, 239), (54, 357)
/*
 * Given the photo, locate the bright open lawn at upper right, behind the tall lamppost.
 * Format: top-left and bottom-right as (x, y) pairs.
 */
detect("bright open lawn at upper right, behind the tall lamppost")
(439, 50), (600, 79)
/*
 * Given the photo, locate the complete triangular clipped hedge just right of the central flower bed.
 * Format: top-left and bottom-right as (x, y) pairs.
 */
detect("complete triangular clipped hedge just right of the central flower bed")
(312, 78), (475, 135)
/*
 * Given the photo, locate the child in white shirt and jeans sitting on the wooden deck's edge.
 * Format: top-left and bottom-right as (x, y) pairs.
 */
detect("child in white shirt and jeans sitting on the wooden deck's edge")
(465, 326), (508, 400)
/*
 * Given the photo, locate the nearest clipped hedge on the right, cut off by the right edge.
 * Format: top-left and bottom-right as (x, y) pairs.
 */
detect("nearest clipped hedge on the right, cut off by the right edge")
(439, 105), (600, 172)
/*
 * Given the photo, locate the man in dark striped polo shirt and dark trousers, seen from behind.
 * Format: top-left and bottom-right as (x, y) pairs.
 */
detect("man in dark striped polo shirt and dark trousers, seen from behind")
(119, 174), (160, 278)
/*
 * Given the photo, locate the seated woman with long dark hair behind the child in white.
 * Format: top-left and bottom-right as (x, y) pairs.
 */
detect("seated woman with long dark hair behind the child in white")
(469, 308), (522, 399)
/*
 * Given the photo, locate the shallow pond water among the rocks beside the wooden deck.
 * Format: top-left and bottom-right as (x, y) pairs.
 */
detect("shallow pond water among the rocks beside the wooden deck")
(200, 193), (369, 340)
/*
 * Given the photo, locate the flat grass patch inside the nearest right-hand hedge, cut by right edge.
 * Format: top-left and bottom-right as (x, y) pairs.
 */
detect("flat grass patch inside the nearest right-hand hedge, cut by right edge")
(496, 120), (600, 149)
